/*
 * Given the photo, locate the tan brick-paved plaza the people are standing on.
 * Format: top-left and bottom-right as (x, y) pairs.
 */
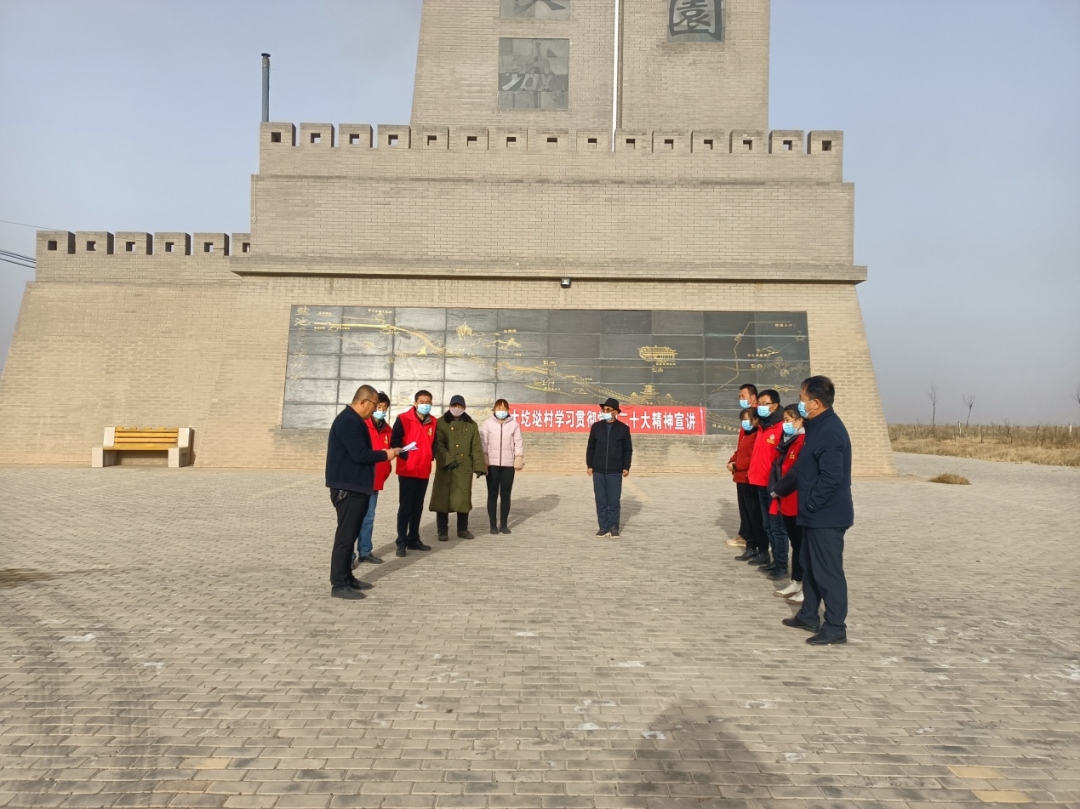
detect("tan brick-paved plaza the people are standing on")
(0, 456), (1080, 809)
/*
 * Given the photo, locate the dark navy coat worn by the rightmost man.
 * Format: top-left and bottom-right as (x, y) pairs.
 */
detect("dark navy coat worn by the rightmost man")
(794, 408), (855, 528)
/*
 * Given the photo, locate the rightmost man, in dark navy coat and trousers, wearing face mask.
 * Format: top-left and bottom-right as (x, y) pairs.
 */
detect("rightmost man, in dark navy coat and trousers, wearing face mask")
(783, 376), (855, 646)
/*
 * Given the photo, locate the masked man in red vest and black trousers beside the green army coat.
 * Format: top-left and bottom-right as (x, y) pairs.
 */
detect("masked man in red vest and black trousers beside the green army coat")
(390, 390), (435, 556)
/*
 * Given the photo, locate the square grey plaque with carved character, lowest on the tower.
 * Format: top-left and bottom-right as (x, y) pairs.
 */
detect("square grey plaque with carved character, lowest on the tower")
(499, 37), (570, 109)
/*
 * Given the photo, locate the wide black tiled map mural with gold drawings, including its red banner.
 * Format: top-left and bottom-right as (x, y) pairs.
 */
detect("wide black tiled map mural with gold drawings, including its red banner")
(282, 306), (810, 434)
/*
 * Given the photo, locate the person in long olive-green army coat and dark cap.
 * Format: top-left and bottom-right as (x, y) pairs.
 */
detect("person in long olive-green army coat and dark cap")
(428, 395), (487, 542)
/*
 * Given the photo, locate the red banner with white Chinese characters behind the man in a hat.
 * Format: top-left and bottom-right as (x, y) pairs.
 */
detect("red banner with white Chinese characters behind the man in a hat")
(512, 405), (705, 435)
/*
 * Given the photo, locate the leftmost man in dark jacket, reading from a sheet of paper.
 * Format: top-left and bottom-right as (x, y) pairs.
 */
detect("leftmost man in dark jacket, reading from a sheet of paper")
(326, 385), (397, 598)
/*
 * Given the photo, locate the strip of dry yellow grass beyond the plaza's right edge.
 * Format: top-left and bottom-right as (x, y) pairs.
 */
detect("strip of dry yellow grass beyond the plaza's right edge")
(889, 423), (1080, 467)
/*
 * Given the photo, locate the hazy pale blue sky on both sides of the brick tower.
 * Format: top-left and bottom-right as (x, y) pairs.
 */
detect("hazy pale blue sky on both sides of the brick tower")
(0, 0), (1080, 423)
